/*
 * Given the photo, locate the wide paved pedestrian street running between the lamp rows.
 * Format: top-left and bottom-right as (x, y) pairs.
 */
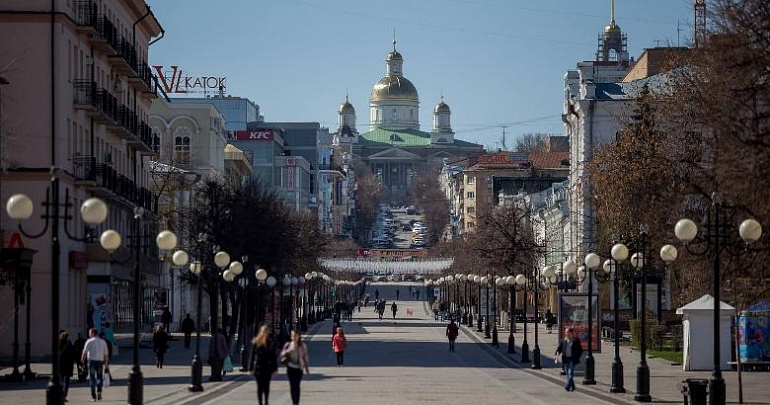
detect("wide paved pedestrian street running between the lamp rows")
(0, 284), (770, 405)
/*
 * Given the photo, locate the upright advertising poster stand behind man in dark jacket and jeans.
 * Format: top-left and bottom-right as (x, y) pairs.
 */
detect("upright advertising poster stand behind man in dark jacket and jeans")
(559, 293), (601, 353)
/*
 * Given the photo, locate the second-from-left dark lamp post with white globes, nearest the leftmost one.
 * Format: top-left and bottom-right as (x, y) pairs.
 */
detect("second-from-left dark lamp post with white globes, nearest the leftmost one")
(99, 207), (188, 405)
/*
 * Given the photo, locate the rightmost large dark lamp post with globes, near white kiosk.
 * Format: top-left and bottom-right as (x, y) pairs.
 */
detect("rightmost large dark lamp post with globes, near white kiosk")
(661, 198), (762, 405)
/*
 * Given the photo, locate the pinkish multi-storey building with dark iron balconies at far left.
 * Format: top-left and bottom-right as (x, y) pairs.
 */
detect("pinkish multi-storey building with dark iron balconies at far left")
(0, 0), (163, 364)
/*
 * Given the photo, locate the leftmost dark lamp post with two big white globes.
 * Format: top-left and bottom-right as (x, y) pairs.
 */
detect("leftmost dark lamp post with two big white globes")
(6, 190), (107, 405)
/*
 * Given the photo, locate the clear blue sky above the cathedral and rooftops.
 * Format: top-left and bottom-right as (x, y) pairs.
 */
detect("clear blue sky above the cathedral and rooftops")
(146, 0), (694, 150)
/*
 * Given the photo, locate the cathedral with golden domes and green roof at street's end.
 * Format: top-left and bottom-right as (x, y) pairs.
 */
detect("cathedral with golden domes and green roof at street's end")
(334, 41), (484, 205)
